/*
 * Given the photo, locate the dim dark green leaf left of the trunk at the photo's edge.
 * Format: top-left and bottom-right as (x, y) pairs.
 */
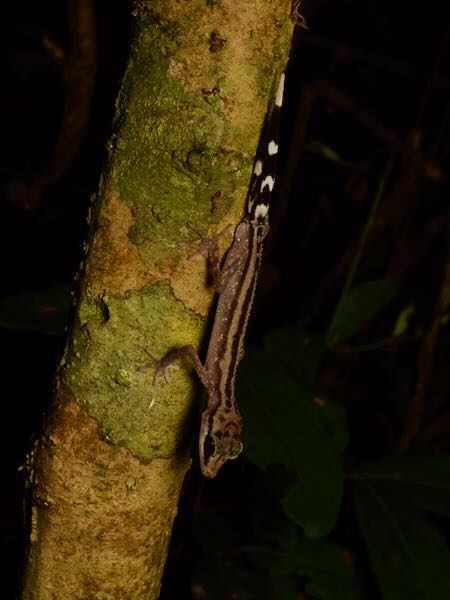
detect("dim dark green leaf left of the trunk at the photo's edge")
(0, 283), (71, 336)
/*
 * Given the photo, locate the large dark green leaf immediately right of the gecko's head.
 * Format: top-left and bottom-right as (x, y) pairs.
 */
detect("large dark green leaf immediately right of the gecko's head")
(236, 348), (342, 537)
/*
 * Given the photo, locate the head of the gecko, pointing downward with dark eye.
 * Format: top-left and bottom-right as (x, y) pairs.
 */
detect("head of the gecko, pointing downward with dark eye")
(199, 407), (243, 478)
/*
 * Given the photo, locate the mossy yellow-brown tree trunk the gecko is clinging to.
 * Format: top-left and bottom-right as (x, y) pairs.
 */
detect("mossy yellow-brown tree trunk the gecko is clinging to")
(21, 0), (292, 600)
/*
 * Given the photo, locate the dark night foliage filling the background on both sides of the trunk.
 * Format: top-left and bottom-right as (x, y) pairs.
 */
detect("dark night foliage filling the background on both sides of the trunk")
(0, 0), (450, 600)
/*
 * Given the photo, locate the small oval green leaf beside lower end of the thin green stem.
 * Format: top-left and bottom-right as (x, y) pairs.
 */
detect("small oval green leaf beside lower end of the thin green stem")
(329, 279), (398, 345)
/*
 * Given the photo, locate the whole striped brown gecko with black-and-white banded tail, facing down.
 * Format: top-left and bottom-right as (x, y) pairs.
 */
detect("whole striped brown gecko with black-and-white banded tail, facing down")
(148, 72), (285, 478)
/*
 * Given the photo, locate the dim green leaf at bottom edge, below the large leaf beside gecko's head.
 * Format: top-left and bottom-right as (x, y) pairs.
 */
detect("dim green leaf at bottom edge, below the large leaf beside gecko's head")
(245, 537), (364, 600)
